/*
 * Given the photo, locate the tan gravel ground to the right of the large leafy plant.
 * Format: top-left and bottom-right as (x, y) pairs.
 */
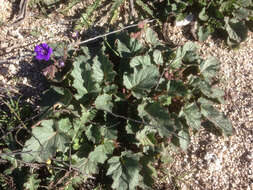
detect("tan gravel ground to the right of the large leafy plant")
(163, 23), (253, 190)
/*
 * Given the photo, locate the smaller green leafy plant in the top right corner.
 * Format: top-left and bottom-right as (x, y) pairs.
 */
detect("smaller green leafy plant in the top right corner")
(158, 0), (253, 46)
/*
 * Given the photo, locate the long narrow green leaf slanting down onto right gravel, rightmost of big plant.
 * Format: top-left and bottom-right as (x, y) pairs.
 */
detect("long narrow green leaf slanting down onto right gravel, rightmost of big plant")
(198, 98), (233, 136)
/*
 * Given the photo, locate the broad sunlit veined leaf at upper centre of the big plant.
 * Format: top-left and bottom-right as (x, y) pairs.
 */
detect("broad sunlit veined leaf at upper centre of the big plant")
(123, 65), (159, 98)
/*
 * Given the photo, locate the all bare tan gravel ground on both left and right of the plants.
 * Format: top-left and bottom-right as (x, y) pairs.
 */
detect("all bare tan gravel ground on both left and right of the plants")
(0, 0), (253, 190)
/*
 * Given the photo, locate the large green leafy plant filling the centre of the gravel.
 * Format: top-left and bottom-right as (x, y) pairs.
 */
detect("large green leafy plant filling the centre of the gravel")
(17, 27), (232, 190)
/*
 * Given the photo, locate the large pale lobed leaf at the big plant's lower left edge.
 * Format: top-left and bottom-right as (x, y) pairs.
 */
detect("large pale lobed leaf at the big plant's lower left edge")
(22, 120), (70, 162)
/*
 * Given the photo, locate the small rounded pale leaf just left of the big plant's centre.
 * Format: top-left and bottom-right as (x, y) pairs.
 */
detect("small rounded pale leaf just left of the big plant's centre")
(95, 94), (113, 112)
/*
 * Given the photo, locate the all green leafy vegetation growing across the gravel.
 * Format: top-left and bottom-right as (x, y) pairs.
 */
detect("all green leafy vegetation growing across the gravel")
(0, 0), (252, 190)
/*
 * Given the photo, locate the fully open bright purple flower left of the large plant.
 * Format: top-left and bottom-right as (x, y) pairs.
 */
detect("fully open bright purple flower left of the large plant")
(34, 43), (53, 61)
